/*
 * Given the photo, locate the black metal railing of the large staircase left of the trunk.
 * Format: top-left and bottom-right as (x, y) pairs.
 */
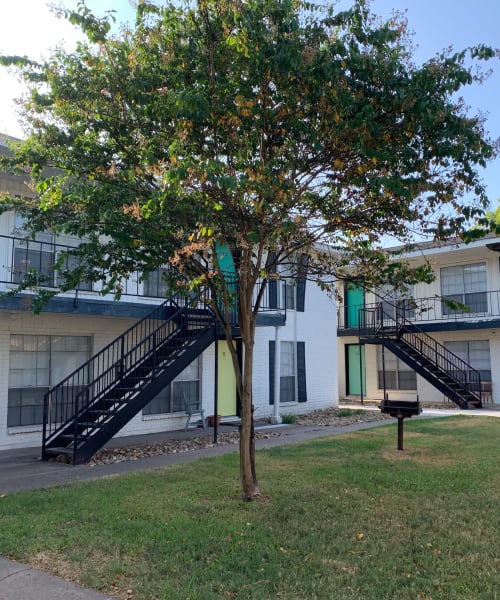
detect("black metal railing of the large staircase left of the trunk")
(43, 294), (214, 447)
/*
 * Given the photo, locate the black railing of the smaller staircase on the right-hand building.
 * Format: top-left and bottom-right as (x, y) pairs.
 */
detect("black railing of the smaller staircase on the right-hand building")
(359, 303), (481, 401)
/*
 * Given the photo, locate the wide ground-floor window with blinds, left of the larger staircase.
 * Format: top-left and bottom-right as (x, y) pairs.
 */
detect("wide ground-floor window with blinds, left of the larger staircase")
(7, 335), (90, 427)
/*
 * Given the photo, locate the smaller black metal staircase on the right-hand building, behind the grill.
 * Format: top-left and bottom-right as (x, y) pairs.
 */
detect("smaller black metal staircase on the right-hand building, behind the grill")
(359, 303), (482, 409)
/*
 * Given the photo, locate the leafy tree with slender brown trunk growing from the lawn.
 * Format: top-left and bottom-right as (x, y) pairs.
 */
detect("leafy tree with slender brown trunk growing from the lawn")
(3, 0), (495, 499)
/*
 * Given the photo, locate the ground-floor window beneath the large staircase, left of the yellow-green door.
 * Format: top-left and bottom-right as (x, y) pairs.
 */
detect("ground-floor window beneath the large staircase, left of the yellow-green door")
(142, 358), (201, 415)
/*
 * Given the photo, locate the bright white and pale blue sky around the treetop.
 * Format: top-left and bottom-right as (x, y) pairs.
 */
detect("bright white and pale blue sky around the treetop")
(0, 0), (500, 208)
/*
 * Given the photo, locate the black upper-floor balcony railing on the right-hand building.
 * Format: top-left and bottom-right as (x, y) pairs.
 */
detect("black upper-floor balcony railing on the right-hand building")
(338, 290), (500, 331)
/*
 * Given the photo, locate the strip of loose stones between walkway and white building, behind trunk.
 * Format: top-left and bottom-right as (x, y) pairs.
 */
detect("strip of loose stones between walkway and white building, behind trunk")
(87, 408), (390, 467)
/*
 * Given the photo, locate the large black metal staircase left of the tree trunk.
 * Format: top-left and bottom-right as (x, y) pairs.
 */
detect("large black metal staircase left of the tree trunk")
(42, 295), (217, 464)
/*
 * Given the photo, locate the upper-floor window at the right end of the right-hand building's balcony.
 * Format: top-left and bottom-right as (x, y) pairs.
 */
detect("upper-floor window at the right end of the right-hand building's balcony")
(441, 263), (488, 315)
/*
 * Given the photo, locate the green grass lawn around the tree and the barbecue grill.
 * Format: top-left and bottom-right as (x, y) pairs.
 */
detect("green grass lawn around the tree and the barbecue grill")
(0, 417), (500, 600)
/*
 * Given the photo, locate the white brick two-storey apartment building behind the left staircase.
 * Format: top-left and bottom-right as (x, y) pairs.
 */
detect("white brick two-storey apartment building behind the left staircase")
(0, 136), (338, 454)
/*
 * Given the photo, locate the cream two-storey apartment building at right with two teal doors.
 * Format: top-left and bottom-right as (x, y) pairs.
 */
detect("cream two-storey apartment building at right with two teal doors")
(338, 235), (500, 408)
